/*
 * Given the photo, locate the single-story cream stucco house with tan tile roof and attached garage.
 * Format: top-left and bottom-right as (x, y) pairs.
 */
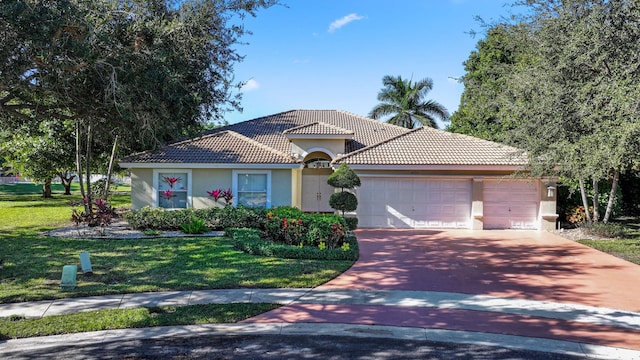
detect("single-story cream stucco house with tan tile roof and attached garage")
(120, 110), (558, 230)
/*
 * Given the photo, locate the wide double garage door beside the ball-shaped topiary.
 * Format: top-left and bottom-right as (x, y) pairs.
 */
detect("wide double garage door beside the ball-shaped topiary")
(357, 177), (471, 229)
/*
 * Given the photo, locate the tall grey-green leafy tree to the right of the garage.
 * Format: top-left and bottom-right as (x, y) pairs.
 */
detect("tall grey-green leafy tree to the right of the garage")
(454, 0), (640, 222)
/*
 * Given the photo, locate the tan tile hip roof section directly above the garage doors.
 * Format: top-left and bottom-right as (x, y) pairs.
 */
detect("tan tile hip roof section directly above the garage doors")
(334, 127), (527, 166)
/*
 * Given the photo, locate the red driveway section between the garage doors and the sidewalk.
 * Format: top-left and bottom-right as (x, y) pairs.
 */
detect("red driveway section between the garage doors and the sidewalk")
(323, 229), (640, 312)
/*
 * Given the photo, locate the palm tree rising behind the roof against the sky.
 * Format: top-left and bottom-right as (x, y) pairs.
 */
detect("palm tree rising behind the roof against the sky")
(369, 75), (449, 129)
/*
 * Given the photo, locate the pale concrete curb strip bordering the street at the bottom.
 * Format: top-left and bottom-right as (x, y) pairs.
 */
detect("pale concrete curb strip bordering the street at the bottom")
(0, 323), (640, 359)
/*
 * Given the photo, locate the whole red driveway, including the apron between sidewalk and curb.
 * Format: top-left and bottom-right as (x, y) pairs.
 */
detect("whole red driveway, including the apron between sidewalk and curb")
(246, 230), (640, 350)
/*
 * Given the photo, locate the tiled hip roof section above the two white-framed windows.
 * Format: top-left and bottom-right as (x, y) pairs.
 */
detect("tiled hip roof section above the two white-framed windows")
(121, 130), (300, 164)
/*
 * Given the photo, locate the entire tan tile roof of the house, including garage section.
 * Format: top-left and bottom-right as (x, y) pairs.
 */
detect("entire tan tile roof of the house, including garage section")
(120, 110), (526, 166)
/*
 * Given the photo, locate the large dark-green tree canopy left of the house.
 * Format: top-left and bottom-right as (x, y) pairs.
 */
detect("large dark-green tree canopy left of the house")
(0, 0), (276, 202)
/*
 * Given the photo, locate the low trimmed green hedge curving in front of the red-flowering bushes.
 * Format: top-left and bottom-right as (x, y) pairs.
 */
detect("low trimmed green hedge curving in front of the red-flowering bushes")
(226, 228), (359, 261)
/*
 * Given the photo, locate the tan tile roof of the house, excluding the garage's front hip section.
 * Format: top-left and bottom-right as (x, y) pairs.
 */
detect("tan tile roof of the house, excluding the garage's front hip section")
(120, 110), (409, 164)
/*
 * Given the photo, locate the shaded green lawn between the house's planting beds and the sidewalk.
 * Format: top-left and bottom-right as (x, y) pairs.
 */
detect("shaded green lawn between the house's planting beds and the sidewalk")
(0, 188), (353, 302)
